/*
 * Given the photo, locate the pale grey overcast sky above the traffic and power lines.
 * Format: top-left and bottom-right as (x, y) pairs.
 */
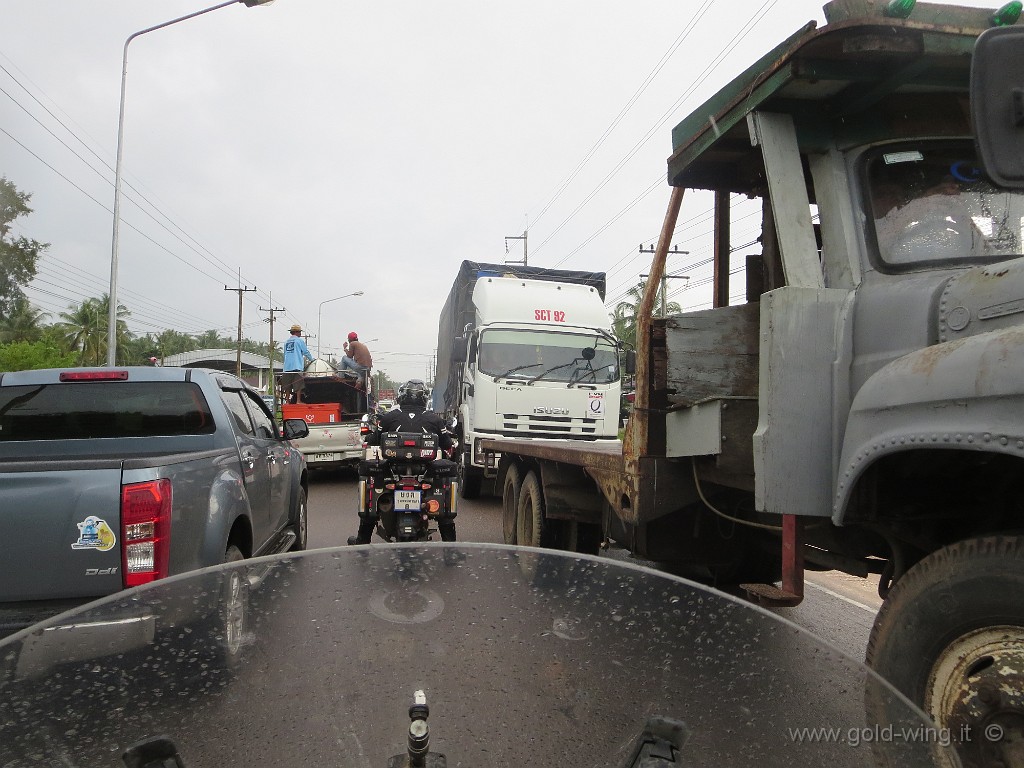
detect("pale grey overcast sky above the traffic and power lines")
(0, 0), (997, 379)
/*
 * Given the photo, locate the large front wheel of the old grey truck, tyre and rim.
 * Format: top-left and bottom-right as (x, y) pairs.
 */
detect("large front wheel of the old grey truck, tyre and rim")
(866, 536), (1024, 766)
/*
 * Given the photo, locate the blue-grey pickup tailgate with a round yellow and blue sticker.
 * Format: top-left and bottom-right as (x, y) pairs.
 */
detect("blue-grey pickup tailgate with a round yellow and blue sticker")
(0, 460), (123, 602)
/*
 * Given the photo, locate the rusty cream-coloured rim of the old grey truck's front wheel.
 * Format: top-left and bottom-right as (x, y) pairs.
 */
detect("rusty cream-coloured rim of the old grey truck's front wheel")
(924, 625), (1024, 765)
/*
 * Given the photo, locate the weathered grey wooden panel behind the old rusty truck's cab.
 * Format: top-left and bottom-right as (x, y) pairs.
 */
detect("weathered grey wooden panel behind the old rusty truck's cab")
(666, 304), (759, 404)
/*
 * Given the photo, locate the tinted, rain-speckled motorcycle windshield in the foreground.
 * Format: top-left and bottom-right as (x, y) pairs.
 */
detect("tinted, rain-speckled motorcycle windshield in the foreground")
(0, 544), (955, 768)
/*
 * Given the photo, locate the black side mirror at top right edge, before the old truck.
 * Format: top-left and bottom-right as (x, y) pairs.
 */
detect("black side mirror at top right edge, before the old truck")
(971, 27), (1024, 189)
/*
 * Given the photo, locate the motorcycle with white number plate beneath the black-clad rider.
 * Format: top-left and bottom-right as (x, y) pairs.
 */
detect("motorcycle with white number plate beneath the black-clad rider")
(358, 415), (458, 542)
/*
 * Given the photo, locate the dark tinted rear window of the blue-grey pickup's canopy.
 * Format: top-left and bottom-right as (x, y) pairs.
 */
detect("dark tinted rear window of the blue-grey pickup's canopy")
(0, 381), (215, 441)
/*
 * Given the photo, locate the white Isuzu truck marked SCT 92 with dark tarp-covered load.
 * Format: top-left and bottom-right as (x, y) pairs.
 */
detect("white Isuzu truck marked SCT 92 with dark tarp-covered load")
(432, 261), (621, 499)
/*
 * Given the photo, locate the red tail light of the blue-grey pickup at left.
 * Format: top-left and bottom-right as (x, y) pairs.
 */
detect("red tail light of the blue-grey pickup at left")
(121, 478), (171, 587)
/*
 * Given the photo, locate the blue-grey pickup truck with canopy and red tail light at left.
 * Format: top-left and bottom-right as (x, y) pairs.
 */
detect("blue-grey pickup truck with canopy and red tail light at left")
(0, 367), (308, 651)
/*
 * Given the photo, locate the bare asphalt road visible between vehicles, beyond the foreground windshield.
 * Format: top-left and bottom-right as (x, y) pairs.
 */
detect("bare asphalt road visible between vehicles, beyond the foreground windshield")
(309, 471), (882, 660)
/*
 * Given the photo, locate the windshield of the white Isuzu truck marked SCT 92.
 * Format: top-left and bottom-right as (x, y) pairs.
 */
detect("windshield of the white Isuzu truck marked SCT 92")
(478, 329), (618, 384)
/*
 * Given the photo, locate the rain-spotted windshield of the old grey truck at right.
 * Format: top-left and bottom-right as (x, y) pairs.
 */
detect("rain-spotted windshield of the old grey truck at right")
(866, 141), (1024, 267)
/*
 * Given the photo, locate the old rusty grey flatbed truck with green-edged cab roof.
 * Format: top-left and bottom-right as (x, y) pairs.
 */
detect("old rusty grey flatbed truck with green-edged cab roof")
(481, 0), (1024, 765)
